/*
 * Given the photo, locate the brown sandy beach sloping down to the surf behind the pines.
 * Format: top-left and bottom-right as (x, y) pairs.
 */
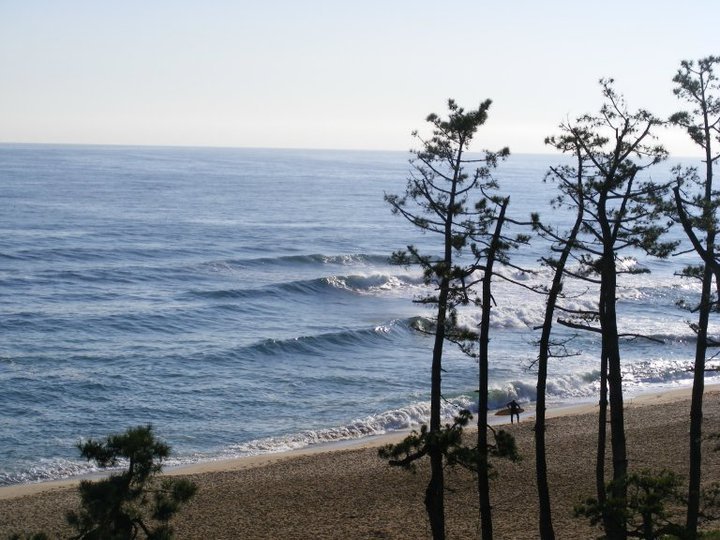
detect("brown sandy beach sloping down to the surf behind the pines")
(0, 387), (720, 540)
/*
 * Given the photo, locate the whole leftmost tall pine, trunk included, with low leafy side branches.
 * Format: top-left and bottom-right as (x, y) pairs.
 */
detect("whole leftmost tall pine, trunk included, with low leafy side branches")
(381, 100), (509, 540)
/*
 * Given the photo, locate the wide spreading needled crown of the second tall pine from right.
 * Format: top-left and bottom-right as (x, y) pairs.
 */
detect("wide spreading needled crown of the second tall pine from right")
(544, 79), (677, 316)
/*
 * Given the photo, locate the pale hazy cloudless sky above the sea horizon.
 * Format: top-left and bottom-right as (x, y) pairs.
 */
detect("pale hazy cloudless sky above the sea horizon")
(0, 0), (720, 155)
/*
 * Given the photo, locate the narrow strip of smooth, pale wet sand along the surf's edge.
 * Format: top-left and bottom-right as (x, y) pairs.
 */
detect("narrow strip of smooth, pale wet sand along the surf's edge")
(0, 384), (708, 500)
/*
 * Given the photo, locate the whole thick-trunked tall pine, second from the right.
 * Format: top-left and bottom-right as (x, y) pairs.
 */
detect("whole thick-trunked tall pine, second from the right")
(548, 79), (674, 539)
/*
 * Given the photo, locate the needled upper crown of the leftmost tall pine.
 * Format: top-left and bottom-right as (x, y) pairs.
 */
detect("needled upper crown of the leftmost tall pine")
(385, 99), (510, 305)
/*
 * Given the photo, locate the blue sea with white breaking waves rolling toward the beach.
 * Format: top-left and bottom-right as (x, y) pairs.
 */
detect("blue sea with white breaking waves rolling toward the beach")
(0, 145), (716, 485)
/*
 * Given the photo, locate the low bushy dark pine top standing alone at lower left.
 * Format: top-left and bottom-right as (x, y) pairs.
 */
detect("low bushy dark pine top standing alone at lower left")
(67, 425), (197, 540)
